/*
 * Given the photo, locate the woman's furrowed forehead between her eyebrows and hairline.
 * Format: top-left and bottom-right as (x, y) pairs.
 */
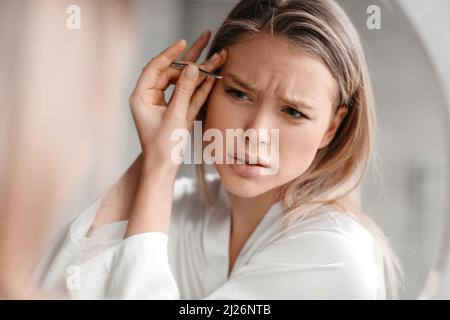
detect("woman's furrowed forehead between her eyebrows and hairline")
(222, 35), (337, 109)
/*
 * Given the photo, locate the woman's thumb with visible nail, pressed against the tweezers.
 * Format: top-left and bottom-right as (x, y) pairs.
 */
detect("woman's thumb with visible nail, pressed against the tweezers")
(169, 63), (199, 116)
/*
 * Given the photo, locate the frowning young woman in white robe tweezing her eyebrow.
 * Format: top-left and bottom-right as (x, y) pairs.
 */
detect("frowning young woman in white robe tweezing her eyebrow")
(33, 0), (399, 299)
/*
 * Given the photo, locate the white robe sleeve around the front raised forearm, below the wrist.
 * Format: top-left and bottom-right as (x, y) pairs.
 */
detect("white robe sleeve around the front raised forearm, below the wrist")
(71, 232), (179, 299)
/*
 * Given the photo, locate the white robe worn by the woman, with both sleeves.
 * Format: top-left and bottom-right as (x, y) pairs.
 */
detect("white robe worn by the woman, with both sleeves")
(35, 178), (385, 299)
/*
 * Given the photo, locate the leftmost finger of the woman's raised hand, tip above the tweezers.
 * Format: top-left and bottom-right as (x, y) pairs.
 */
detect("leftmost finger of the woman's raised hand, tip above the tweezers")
(136, 39), (187, 92)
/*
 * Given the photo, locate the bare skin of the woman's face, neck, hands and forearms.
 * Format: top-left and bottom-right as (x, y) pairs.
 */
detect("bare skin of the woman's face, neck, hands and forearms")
(89, 32), (346, 271)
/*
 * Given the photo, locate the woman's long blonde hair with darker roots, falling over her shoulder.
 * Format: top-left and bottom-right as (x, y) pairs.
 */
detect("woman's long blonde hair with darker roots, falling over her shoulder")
(196, 0), (403, 298)
